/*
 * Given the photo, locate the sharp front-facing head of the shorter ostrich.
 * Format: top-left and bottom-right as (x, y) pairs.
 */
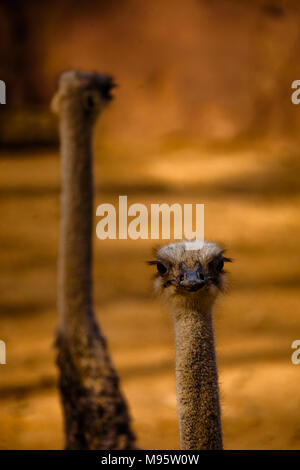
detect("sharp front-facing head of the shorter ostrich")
(149, 241), (231, 307)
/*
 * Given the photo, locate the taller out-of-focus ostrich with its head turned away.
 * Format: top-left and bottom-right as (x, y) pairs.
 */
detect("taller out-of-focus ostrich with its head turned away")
(52, 71), (136, 449)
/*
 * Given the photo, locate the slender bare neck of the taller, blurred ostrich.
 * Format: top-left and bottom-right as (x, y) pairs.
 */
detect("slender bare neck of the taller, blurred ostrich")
(58, 108), (93, 334)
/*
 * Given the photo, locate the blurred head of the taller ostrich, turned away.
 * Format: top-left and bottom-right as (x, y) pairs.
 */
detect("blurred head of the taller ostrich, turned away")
(51, 70), (116, 121)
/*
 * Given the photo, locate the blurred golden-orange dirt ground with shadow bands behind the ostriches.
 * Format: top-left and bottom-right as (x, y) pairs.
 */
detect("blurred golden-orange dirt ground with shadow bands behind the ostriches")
(0, 136), (300, 449)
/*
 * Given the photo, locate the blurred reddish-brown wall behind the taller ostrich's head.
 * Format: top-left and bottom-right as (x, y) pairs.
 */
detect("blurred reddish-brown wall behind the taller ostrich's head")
(0, 0), (300, 144)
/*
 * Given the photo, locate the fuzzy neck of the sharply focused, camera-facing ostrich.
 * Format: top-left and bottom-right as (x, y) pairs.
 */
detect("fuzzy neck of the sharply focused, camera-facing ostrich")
(175, 305), (222, 450)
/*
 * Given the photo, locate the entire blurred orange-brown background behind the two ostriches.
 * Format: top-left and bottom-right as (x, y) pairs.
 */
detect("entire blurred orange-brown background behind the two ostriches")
(0, 0), (300, 449)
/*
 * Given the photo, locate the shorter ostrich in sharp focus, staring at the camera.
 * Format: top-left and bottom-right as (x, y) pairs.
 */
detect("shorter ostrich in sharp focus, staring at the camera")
(149, 241), (231, 450)
